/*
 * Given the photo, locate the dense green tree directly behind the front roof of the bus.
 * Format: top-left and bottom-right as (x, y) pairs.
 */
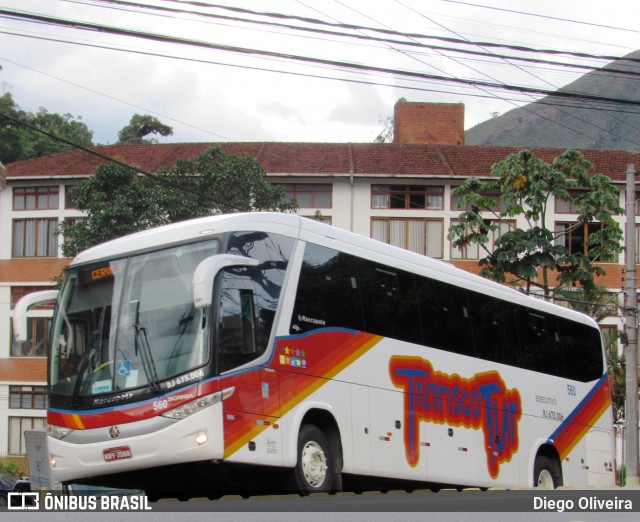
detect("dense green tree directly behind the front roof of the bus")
(60, 147), (298, 257)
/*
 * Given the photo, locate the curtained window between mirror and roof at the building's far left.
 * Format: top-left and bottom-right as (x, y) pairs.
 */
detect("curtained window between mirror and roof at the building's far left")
(13, 219), (58, 257)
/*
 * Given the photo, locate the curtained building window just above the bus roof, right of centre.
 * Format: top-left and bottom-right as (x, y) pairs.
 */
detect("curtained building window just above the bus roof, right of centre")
(371, 218), (443, 258)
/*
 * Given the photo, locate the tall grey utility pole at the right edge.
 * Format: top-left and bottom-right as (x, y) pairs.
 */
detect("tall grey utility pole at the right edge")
(624, 163), (640, 487)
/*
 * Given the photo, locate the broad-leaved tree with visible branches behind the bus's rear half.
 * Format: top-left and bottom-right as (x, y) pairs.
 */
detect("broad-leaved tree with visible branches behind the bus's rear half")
(448, 150), (623, 296)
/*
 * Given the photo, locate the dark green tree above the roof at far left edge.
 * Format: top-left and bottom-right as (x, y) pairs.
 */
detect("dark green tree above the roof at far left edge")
(0, 92), (93, 163)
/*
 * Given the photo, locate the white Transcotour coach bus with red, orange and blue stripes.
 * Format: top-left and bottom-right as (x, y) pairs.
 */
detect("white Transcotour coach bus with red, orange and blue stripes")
(14, 213), (615, 493)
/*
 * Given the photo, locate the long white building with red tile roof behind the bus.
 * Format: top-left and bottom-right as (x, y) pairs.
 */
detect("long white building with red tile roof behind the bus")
(0, 102), (637, 455)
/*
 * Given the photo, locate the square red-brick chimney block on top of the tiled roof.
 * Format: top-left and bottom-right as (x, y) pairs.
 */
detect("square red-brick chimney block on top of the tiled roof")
(393, 99), (464, 145)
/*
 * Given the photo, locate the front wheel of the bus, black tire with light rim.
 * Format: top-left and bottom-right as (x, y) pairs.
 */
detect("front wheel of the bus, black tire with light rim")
(294, 424), (335, 495)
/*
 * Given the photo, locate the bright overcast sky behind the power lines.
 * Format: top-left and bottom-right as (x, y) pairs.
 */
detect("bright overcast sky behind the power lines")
(0, 0), (640, 143)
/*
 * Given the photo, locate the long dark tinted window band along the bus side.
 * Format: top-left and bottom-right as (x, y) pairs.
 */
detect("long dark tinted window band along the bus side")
(291, 244), (604, 382)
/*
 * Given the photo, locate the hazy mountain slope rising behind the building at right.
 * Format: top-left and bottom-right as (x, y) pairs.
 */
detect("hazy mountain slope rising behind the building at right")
(465, 51), (640, 150)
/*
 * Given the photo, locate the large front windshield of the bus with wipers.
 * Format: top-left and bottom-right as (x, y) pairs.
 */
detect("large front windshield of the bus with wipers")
(49, 241), (218, 402)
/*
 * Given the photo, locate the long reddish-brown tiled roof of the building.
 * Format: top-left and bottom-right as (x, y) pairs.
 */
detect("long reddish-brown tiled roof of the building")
(7, 142), (640, 181)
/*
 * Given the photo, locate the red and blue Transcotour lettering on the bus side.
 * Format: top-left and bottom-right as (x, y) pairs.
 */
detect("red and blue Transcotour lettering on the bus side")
(389, 356), (522, 479)
